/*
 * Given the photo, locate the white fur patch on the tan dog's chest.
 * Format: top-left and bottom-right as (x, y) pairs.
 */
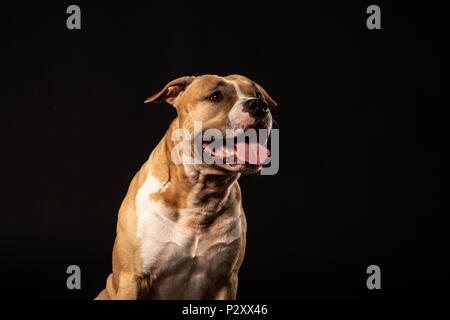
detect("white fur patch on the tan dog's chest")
(136, 173), (242, 299)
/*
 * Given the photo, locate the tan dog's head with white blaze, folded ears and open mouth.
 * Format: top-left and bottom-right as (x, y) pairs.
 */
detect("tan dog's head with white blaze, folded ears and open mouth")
(145, 75), (277, 173)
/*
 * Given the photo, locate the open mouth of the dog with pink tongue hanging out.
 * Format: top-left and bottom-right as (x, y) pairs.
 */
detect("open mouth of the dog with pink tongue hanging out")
(202, 137), (270, 166)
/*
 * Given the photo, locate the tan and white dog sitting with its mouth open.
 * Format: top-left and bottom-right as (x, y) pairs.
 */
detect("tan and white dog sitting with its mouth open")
(96, 75), (276, 299)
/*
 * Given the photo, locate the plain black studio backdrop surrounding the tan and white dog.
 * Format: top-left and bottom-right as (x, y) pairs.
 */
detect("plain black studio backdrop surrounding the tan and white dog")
(0, 1), (450, 299)
